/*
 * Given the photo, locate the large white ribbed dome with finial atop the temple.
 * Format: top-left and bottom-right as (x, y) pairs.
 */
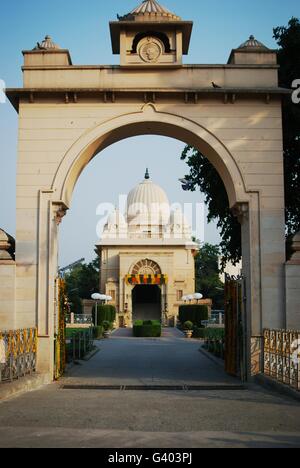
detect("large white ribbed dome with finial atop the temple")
(127, 170), (170, 225)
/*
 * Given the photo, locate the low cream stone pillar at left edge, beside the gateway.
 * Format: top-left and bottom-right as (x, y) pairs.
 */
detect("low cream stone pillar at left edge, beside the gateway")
(0, 229), (16, 331)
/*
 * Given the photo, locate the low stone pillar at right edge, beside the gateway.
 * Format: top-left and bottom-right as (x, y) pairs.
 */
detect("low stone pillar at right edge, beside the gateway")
(285, 232), (300, 330)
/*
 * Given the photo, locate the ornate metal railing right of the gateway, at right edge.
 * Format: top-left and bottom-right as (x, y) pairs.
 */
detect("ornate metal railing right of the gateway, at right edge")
(264, 330), (300, 391)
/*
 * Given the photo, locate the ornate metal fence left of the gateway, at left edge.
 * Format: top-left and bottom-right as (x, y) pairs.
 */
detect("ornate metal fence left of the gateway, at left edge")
(0, 328), (37, 384)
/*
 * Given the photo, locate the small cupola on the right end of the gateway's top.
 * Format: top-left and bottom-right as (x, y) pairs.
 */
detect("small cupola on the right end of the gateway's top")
(228, 36), (277, 65)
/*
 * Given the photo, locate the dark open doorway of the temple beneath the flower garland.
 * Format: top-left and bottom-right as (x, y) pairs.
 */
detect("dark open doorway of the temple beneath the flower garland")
(132, 285), (162, 323)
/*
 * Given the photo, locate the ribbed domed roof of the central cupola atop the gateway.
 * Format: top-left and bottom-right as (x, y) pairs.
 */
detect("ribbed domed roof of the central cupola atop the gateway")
(118, 0), (181, 21)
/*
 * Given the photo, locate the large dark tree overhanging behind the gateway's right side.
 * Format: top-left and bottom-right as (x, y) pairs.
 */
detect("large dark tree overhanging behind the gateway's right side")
(181, 18), (300, 267)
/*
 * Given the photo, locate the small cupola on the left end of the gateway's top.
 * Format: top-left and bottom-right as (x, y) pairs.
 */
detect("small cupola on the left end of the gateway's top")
(23, 36), (72, 67)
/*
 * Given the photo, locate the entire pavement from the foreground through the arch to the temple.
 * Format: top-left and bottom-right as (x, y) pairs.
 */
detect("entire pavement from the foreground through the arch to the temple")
(0, 331), (300, 448)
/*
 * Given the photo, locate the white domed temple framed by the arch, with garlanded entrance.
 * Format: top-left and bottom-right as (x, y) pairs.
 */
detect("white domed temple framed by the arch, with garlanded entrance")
(96, 170), (197, 326)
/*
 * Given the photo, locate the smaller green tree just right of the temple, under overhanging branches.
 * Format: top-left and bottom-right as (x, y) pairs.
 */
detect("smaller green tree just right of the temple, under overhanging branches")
(195, 244), (224, 309)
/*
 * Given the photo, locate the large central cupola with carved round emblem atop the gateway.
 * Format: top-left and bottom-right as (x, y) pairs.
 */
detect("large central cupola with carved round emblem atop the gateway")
(110, 0), (193, 67)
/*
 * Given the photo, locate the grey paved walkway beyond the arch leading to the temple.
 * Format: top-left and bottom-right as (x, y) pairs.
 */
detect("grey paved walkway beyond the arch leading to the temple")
(63, 328), (239, 385)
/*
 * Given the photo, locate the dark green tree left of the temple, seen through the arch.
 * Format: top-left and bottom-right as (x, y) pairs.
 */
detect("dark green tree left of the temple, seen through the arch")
(65, 257), (99, 314)
